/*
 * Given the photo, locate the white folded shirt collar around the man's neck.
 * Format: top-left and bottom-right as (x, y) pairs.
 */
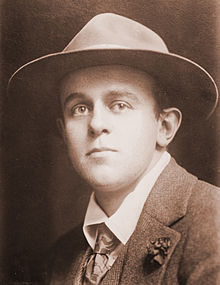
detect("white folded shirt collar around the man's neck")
(83, 151), (171, 249)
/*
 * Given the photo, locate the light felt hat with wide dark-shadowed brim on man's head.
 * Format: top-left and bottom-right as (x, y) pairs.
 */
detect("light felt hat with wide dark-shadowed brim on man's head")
(8, 13), (218, 133)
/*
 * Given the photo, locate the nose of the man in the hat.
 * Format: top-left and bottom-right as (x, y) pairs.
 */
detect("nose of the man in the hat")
(88, 104), (110, 137)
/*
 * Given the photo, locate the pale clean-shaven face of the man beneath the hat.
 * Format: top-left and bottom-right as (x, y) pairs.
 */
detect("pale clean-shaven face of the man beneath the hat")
(60, 65), (161, 192)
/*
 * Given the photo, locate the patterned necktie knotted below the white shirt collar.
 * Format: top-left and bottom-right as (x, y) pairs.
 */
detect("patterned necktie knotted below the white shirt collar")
(83, 223), (122, 285)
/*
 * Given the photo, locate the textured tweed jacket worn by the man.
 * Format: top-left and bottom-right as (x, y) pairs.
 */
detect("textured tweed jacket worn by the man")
(47, 159), (220, 285)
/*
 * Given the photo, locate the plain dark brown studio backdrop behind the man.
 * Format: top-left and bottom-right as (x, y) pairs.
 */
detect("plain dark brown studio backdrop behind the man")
(0, 0), (220, 282)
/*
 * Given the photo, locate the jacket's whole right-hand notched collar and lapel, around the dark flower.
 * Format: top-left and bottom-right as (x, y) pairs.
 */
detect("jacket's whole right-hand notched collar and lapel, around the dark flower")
(118, 159), (197, 284)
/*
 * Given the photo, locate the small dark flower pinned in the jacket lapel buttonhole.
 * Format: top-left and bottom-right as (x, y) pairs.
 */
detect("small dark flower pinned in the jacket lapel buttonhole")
(147, 237), (171, 265)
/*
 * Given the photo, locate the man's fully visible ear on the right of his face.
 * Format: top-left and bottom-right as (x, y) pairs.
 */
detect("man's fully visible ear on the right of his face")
(157, 107), (182, 148)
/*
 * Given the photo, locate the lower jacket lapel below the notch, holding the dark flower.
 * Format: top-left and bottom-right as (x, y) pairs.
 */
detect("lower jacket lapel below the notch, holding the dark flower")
(121, 212), (180, 284)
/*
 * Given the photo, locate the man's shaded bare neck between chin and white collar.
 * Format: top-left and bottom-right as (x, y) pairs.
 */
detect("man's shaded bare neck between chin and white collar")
(94, 152), (163, 214)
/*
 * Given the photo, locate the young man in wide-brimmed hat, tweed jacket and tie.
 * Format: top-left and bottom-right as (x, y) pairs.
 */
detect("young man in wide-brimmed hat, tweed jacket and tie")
(8, 14), (220, 284)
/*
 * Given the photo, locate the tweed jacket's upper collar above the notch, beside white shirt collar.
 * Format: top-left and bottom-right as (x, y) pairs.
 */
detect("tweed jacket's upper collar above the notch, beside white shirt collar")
(142, 158), (197, 226)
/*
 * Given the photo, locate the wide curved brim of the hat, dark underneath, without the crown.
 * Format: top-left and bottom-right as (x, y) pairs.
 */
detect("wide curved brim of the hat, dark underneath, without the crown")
(8, 48), (218, 134)
